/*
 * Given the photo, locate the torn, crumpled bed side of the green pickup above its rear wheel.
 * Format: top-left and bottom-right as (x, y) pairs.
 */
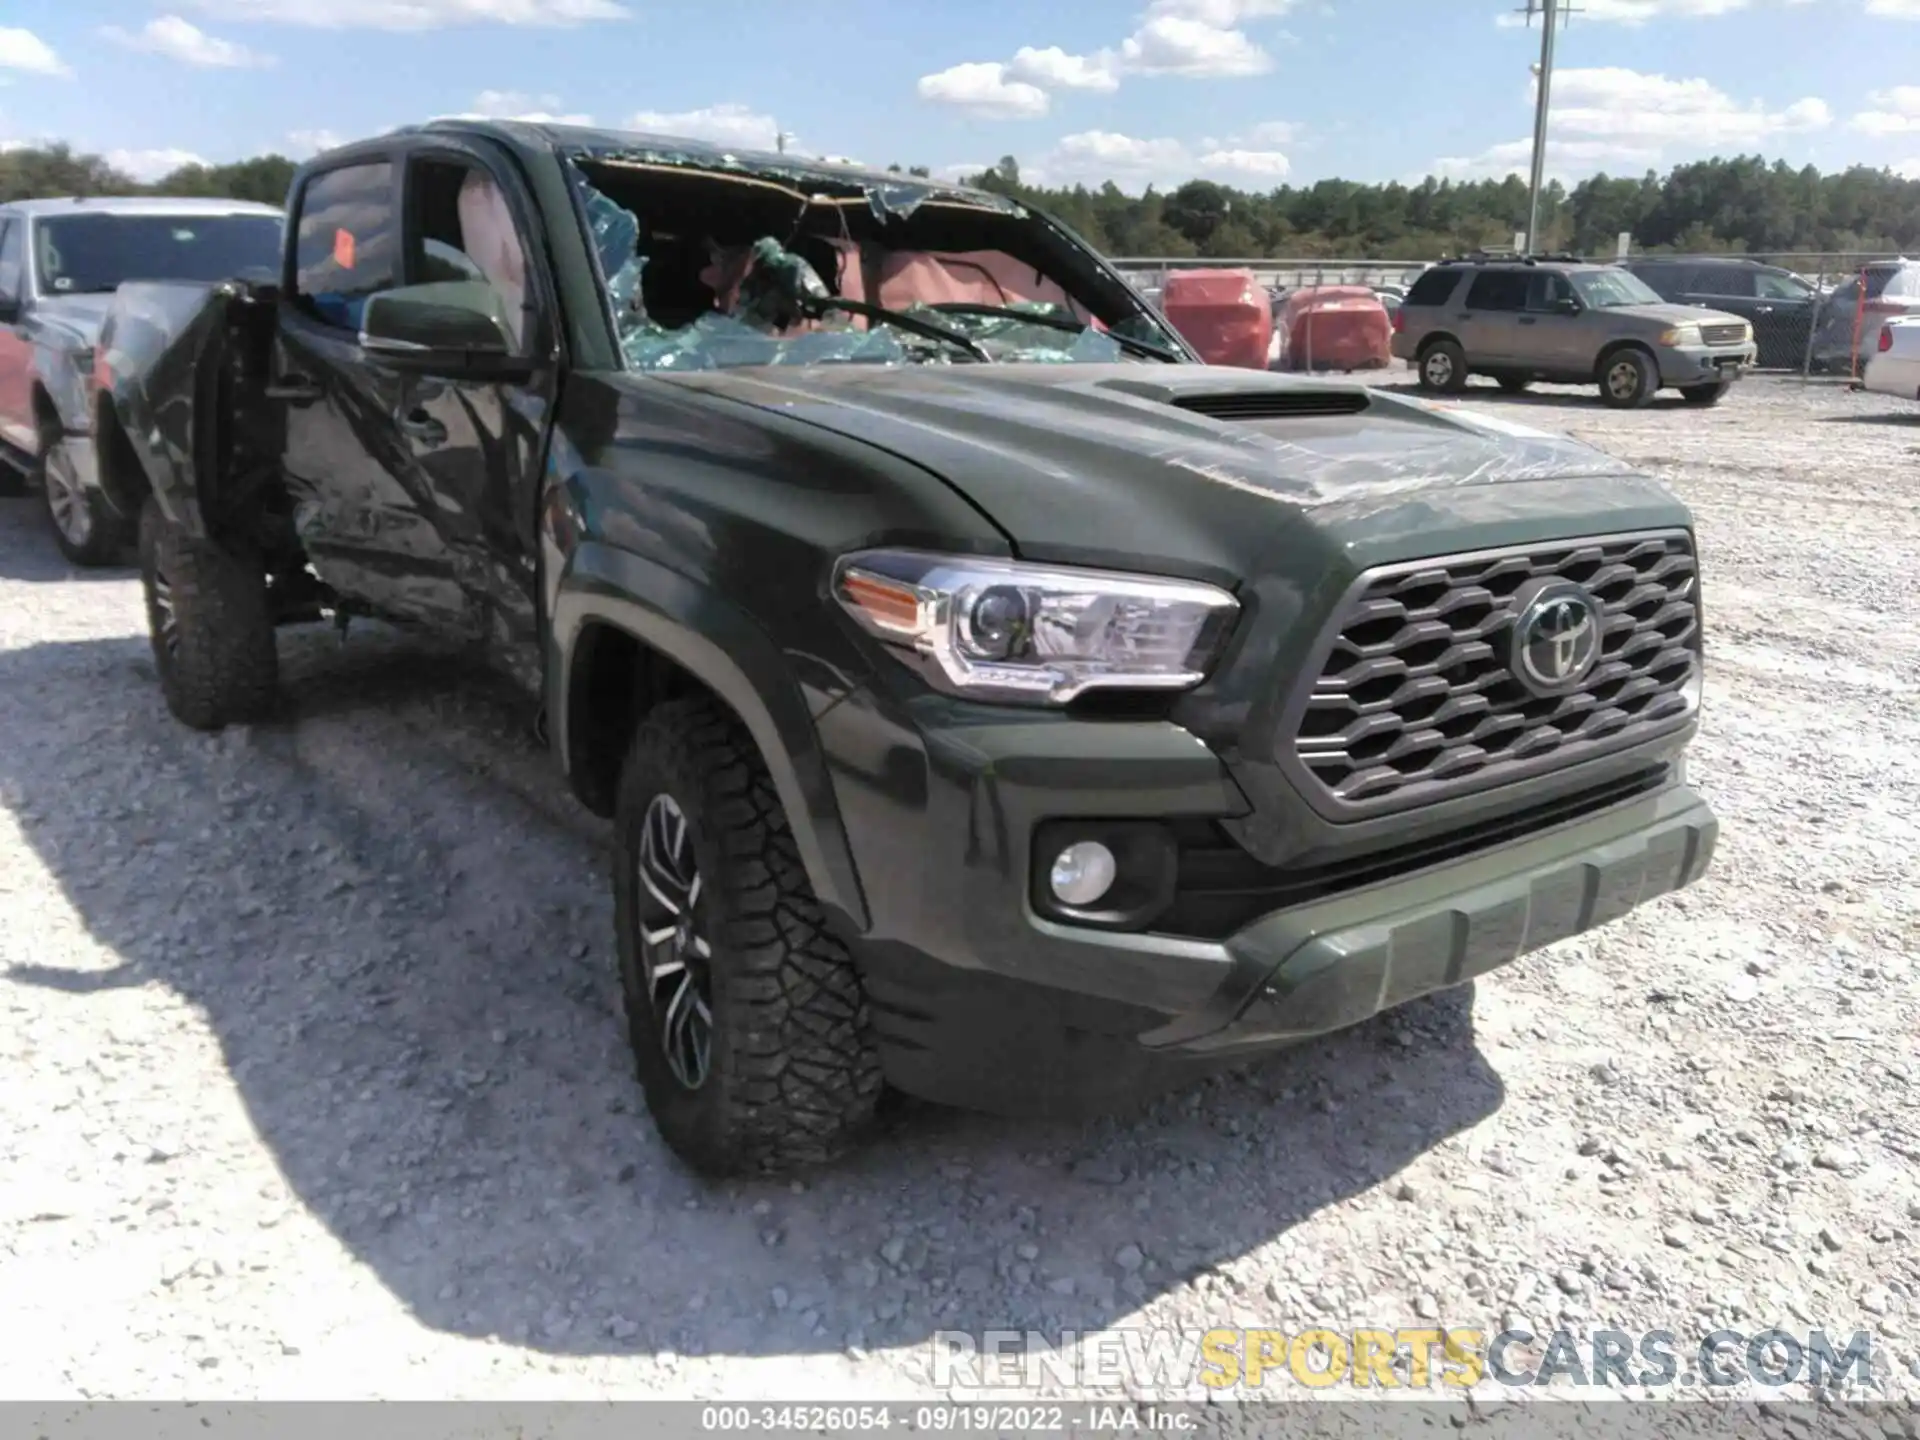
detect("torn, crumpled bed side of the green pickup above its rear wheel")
(94, 280), (284, 541)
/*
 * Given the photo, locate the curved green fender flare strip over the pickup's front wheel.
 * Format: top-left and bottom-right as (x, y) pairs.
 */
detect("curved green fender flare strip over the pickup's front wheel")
(547, 541), (868, 931)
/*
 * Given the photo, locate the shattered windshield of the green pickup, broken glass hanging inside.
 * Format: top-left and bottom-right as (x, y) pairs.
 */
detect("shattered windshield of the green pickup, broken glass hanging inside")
(574, 157), (1185, 371)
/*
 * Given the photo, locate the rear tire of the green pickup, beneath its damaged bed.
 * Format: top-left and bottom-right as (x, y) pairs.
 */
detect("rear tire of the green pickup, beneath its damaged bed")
(140, 499), (280, 730)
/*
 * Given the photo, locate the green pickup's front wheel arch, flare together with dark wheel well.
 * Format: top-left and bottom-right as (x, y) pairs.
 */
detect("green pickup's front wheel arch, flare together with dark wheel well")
(547, 541), (870, 931)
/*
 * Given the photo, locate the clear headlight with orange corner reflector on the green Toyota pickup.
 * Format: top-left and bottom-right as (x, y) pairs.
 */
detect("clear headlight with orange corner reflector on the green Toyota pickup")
(833, 551), (1240, 705)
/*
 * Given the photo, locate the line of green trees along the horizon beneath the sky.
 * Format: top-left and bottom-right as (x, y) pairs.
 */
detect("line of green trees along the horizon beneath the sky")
(0, 144), (1920, 259)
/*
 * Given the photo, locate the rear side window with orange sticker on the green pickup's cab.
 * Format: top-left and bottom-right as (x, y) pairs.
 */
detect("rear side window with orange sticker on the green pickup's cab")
(294, 159), (399, 330)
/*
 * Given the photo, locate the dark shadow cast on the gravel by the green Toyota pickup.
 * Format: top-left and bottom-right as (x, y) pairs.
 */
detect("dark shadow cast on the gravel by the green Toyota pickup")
(0, 630), (1503, 1356)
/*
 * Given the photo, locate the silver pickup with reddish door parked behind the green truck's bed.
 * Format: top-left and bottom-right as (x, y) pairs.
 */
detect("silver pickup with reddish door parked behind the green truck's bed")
(0, 196), (280, 564)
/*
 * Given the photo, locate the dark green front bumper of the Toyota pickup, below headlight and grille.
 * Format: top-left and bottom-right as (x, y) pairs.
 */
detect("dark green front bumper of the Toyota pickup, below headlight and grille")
(820, 699), (1716, 1114)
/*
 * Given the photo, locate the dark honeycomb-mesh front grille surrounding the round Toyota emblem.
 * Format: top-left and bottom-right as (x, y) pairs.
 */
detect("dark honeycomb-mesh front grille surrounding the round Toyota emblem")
(1281, 530), (1699, 818)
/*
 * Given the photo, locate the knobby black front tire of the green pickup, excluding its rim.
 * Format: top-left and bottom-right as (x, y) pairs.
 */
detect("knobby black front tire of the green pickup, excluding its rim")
(614, 695), (883, 1175)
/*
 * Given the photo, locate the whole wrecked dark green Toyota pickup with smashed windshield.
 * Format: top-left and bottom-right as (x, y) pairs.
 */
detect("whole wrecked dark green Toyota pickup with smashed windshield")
(96, 121), (1716, 1171)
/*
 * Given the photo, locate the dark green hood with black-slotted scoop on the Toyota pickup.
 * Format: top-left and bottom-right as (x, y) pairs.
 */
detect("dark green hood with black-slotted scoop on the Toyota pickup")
(656, 365), (1686, 582)
